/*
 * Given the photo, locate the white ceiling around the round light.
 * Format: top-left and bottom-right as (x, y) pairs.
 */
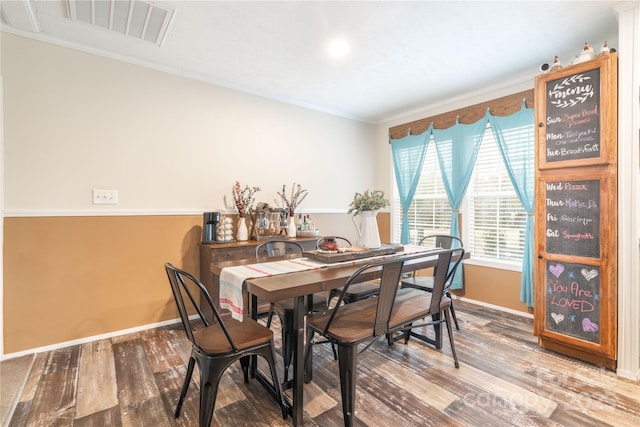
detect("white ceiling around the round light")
(0, 0), (621, 123)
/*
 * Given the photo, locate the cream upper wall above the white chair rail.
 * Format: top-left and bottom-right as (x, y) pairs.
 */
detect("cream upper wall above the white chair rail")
(1, 33), (378, 216)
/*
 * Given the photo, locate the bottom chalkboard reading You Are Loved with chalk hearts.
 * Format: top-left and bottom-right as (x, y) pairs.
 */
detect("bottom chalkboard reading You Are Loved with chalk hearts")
(546, 261), (600, 344)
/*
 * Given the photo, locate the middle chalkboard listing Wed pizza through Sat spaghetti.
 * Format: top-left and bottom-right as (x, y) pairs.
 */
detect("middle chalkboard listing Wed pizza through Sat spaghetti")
(544, 180), (600, 258)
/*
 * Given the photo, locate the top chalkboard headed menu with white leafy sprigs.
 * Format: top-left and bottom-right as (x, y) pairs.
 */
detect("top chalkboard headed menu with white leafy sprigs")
(546, 68), (601, 162)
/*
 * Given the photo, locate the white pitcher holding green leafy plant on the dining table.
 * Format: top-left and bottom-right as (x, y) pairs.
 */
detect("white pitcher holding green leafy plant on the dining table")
(348, 190), (389, 249)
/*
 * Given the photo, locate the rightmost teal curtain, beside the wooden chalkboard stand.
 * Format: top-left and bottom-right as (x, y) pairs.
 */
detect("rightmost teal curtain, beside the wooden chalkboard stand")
(487, 101), (535, 307)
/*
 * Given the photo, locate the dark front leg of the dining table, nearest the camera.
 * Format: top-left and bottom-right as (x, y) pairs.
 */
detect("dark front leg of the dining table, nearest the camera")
(291, 296), (306, 426)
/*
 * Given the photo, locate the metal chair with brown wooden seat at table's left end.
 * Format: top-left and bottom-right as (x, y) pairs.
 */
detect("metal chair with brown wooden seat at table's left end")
(165, 263), (287, 427)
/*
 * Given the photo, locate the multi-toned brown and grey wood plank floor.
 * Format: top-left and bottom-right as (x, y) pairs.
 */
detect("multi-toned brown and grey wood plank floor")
(0, 301), (640, 427)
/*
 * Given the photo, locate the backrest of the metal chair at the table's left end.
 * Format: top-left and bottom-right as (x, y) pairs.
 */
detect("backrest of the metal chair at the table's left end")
(164, 263), (238, 353)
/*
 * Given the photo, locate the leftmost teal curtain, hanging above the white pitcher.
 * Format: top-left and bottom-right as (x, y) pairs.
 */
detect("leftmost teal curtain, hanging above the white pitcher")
(390, 124), (433, 245)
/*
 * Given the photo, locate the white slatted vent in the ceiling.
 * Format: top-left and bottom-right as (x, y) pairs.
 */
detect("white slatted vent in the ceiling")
(67, 0), (173, 46)
